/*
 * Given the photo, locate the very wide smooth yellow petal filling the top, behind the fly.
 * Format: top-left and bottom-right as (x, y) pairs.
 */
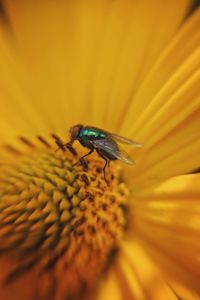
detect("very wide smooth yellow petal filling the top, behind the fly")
(1, 0), (191, 134)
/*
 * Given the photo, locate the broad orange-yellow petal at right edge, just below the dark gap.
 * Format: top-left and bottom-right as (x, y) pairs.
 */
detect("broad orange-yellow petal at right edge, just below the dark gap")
(131, 174), (200, 293)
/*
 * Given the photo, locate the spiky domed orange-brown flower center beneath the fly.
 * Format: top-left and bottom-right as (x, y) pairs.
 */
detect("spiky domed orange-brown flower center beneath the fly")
(0, 135), (128, 297)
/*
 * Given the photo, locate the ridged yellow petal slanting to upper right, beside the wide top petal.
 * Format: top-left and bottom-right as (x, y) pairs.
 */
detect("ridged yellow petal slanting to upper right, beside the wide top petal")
(121, 9), (200, 136)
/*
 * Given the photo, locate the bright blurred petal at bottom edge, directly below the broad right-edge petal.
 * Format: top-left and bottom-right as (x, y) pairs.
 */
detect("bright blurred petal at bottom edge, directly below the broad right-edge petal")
(119, 240), (177, 300)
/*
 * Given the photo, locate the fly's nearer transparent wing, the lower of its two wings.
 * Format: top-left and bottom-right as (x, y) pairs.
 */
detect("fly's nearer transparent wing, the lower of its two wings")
(91, 139), (135, 165)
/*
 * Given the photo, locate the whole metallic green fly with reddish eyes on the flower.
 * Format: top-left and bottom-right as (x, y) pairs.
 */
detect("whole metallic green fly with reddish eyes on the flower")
(67, 125), (142, 180)
